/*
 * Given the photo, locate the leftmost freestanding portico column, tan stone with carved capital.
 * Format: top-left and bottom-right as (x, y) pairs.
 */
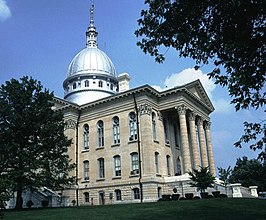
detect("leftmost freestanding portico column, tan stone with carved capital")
(176, 105), (191, 172)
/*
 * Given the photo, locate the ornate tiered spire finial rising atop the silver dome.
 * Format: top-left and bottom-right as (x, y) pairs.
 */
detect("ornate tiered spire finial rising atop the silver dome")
(86, 0), (98, 47)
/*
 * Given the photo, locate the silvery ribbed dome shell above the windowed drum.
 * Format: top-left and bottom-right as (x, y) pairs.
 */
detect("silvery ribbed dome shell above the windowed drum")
(67, 47), (116, 77)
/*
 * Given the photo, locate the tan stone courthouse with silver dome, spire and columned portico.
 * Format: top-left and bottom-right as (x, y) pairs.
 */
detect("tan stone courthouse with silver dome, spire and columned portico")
(54, 3), (215, 205)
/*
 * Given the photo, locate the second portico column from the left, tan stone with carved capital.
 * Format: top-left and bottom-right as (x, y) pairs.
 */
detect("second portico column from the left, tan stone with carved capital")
(188, 112), (200, 169)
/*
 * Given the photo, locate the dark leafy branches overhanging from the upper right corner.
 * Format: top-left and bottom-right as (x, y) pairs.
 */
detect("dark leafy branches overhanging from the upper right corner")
(135, 0), (266, 159)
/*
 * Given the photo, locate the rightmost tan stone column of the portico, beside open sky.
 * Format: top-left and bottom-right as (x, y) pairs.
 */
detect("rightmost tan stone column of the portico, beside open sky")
(204, 121), (216, 176)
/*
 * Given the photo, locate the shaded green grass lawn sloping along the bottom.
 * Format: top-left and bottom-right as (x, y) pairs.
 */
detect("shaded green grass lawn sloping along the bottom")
(3, 199), (266, 220)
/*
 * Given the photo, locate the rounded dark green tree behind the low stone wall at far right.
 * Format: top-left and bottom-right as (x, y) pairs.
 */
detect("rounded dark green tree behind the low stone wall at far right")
(229, 157), (266, 191)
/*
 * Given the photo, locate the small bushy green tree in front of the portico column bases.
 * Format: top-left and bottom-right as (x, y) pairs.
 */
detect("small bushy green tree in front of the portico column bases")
(188, 167), (215, 193)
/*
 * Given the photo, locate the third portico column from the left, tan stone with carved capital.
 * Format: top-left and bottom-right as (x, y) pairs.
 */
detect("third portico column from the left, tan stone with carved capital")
(197, 118), (208, 167)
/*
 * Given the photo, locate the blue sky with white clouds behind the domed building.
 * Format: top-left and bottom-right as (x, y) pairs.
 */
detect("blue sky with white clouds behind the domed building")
(0, 0), (264, 171)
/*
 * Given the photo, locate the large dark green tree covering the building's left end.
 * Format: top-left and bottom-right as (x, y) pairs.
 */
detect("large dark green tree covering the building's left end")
(0, 77), (74, 209)
